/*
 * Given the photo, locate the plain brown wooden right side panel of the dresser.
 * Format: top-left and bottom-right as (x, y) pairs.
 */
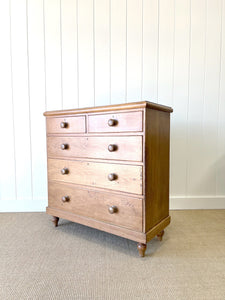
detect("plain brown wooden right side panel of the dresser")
(145, 109), (170, 232)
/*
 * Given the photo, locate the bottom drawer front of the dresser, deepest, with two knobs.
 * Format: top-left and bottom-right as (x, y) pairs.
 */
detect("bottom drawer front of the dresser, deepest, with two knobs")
(48, 182), (142, 231)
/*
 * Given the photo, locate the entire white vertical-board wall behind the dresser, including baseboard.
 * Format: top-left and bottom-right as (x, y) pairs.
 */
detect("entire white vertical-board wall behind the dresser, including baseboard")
(0, 0), (225, 212)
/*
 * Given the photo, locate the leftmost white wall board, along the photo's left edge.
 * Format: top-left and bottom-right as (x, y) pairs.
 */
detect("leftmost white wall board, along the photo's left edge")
(0, 1), (16, 211)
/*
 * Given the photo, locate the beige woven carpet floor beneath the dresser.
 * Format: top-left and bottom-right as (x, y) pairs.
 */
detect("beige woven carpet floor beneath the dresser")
(0, 210), (225, 300)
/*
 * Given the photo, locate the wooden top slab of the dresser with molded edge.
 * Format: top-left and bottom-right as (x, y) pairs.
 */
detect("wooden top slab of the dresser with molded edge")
(44, 101), (173, 117)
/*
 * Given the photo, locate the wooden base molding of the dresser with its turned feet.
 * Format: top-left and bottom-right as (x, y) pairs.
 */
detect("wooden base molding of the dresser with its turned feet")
(46, 207), (170, 257)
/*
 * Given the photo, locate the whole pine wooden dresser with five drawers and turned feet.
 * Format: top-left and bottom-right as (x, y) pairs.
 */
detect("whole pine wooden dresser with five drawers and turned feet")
(44, 102), (173, 256)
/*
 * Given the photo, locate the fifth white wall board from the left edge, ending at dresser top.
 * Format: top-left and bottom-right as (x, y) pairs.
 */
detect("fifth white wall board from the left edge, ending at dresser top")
(61, 0), (79, 109)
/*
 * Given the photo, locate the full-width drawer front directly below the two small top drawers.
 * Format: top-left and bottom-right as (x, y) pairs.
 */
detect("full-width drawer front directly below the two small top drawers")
(47, 136), (142, 161)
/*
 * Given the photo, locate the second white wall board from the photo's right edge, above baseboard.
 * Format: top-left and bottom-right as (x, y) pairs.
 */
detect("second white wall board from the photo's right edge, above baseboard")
(202, 0), (221, 195)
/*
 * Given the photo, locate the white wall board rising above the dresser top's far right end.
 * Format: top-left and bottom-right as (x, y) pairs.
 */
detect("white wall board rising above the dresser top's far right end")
(158, 0), (174, 105)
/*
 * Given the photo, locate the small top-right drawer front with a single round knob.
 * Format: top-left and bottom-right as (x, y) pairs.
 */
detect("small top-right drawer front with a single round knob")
(88, 111), (143, 132)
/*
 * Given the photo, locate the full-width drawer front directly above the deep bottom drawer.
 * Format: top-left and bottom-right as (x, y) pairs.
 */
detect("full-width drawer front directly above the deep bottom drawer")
(48, 158), (142, 195)
